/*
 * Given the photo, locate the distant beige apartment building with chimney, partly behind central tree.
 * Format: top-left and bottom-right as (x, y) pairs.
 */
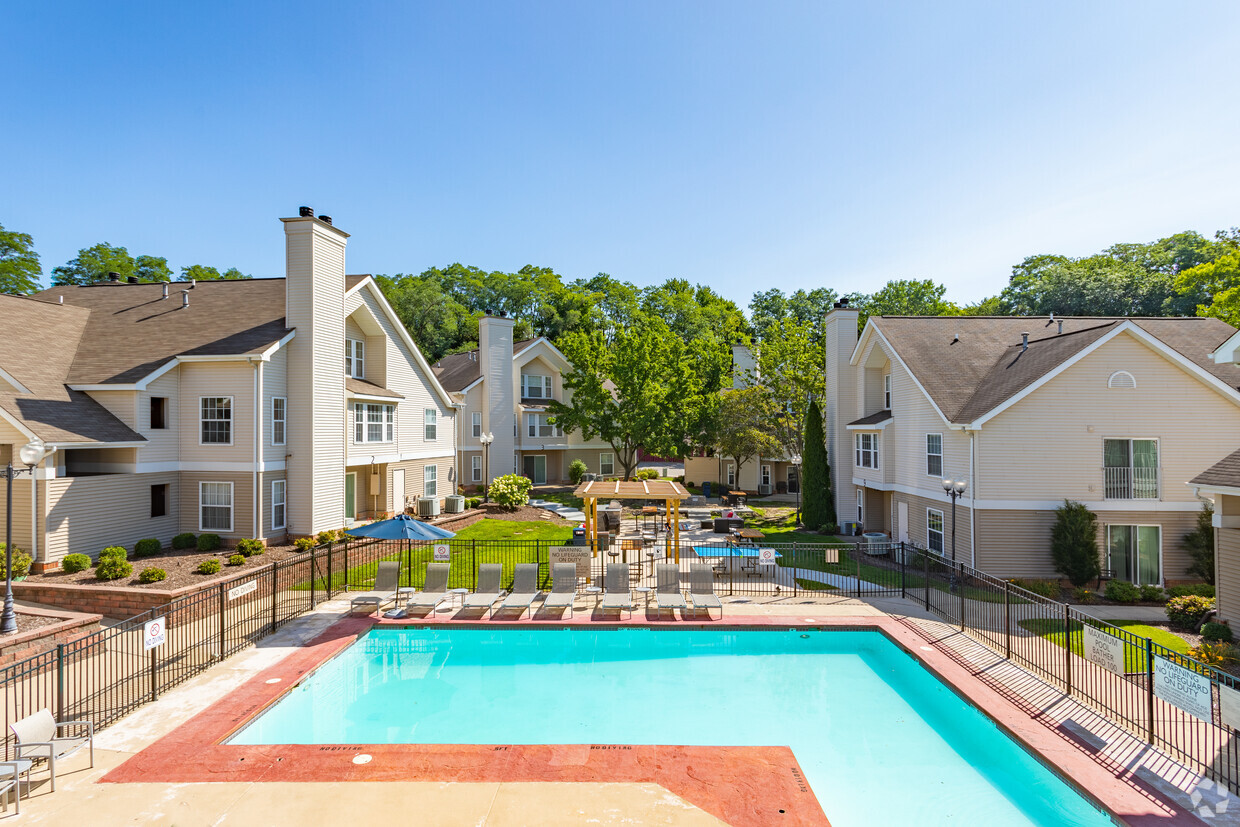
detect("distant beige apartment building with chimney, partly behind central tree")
(434, 316), (619, 486)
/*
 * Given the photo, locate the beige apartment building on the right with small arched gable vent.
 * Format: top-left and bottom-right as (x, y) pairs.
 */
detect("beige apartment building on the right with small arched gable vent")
(825, 304), (1240, 584)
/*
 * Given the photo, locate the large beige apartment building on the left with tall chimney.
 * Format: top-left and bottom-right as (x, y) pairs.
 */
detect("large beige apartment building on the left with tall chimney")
(0, 208), (456, 569)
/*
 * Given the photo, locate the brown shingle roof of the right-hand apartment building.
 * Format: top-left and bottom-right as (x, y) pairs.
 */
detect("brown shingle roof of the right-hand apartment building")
(873, 316), (1240, 423)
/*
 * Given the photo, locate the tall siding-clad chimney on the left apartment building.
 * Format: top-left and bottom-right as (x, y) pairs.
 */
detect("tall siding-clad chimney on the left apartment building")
(280, 208), (348, 534)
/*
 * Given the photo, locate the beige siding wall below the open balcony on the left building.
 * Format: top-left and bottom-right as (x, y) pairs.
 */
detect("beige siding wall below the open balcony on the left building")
(44, 472), (179, 560)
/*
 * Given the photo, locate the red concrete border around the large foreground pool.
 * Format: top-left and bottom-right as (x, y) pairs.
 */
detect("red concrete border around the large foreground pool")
(102, 609), (1203, 827)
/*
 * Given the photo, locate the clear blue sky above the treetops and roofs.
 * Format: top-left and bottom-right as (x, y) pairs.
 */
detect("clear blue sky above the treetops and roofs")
(0, 0), (1240, 305)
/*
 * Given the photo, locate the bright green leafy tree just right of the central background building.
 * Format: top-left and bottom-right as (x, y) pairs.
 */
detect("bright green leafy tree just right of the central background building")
(549, 319), (715, 477)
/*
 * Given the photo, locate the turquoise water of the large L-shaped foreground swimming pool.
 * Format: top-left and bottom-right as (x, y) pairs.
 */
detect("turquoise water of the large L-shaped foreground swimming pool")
(231, 629), (1112, 827)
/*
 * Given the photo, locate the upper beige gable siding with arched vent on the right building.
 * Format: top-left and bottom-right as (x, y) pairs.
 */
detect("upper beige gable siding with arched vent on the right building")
(977, 334), (1240, 506)
